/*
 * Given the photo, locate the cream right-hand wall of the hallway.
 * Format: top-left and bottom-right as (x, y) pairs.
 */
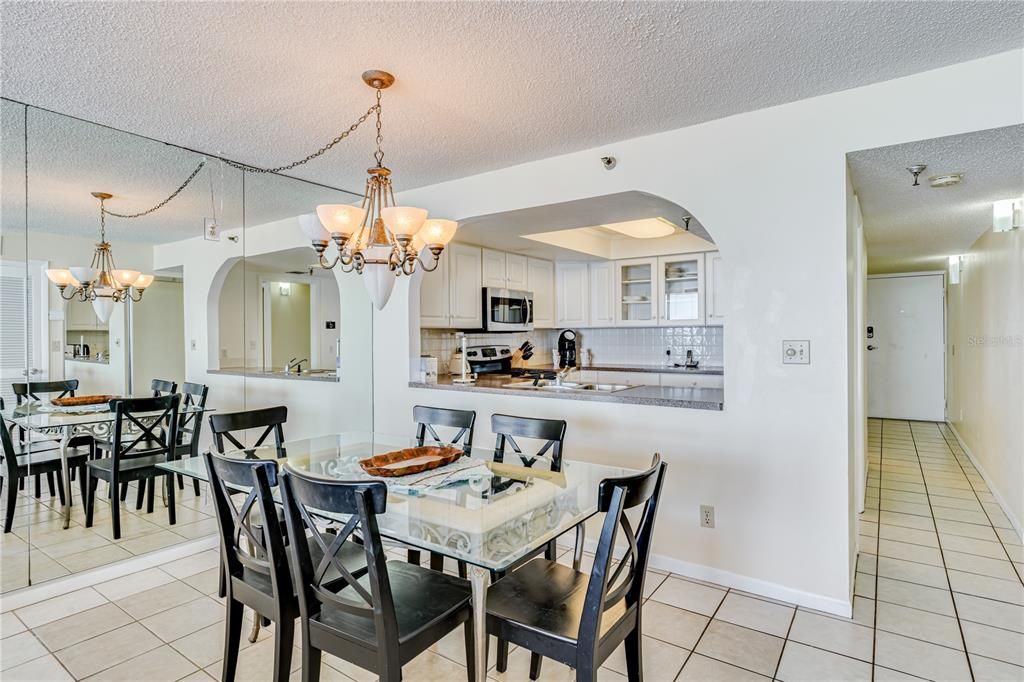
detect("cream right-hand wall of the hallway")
(946, 225), (1024, 535)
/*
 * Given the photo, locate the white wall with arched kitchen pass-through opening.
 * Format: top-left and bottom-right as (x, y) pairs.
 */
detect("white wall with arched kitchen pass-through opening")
(374, 51), (1024, 613)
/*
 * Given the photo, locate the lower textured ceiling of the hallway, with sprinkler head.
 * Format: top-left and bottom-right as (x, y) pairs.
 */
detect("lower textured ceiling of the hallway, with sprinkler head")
(848, 126), (1024, 272)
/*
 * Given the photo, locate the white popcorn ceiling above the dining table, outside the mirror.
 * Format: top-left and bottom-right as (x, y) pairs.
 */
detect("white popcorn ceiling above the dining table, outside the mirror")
(0, 2), (1024, 201)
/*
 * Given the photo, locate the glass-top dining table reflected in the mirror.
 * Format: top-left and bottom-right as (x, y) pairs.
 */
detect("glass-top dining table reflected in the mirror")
(4, 400), (211, 528)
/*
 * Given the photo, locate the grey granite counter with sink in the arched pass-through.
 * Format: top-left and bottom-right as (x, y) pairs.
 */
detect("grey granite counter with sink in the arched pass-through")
(409, 368), (725, 411)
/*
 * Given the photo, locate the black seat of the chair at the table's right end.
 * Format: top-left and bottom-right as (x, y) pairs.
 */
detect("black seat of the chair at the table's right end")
(487, 559), (626, 644)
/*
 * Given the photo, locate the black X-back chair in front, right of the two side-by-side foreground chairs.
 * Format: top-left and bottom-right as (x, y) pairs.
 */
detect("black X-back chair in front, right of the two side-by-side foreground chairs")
(281, 465), (473, 682)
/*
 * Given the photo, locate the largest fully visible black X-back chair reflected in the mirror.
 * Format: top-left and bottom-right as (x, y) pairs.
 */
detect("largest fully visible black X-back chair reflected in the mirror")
(85, 393), (181, 540)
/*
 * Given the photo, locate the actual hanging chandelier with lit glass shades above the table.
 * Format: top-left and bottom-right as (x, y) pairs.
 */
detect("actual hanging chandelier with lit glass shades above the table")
(299, 71), (458, 310)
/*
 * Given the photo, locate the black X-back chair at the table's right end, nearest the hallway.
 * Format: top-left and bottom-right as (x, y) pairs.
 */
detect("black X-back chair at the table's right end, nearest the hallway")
(487, 455), (668, 682)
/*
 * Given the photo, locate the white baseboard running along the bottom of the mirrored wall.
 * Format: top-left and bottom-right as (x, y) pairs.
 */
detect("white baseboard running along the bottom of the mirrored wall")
(0, 536), (220, 613)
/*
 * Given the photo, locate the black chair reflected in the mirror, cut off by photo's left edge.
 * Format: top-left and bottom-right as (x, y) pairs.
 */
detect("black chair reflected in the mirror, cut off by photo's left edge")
(0, 401), (92, 532)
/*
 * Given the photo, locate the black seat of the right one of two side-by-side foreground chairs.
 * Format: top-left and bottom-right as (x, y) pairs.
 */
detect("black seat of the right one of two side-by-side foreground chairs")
(309, 548), (472, 649)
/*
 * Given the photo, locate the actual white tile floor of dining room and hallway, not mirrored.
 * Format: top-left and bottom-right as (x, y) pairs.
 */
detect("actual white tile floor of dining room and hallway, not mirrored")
(0, 420), (1024, 682)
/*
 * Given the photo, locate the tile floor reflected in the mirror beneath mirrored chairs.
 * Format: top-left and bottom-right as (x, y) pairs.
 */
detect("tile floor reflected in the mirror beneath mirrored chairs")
(0, 471), (217, 592)
